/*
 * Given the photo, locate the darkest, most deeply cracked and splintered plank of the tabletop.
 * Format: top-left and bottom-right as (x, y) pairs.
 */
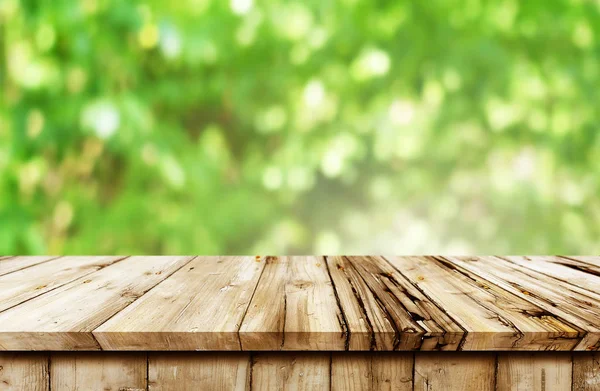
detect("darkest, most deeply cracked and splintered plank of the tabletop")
(342, 256), (465, 350)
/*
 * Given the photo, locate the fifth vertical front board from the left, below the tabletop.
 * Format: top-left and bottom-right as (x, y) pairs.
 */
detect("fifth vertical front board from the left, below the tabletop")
(331, 352), (413, 391)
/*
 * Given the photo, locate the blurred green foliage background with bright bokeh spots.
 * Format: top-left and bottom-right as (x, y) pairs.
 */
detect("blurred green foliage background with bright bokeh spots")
(0, 0), (600, 254)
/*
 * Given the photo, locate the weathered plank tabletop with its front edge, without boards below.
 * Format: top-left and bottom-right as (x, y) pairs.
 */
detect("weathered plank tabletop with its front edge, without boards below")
(0, 256), (600, 352)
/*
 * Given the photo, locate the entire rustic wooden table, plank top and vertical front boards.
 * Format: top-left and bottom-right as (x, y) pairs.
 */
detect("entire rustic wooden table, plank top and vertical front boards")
(0, 256), (600, 391)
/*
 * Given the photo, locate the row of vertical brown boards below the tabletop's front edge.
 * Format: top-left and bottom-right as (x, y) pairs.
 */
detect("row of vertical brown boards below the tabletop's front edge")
(0, 352), (600, 391)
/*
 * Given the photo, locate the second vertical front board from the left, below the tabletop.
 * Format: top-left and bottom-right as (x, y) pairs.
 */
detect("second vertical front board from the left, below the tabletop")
(50, 352), (147, 391)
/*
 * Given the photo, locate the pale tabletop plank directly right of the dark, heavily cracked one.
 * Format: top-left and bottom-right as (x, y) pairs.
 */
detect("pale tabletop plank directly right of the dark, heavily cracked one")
(389, 257), (581, 350)
